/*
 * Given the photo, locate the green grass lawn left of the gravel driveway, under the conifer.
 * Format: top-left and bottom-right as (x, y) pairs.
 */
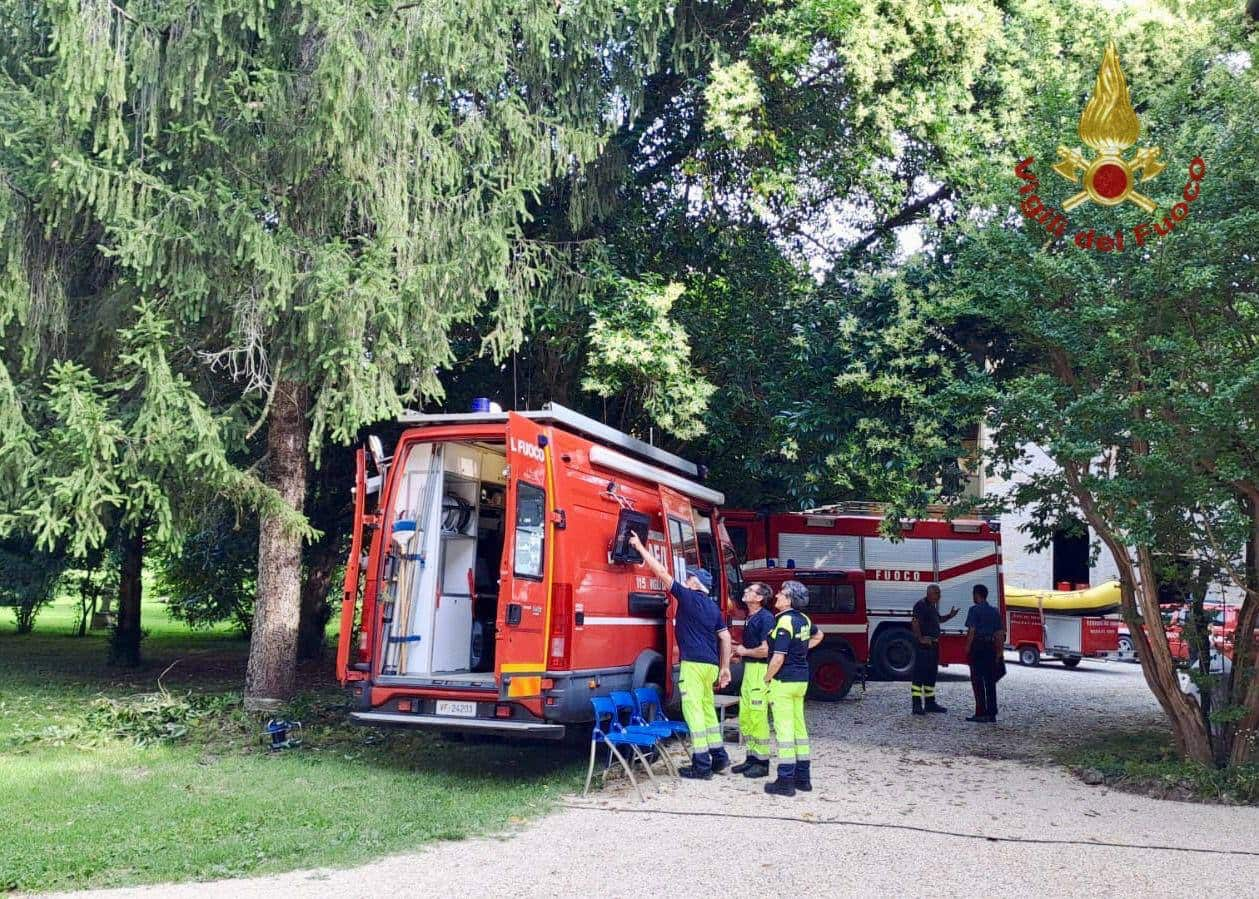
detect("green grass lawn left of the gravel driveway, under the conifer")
(0, 602), (580, 891)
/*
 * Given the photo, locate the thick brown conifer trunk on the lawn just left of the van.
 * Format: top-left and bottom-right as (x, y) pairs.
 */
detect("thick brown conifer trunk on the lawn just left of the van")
(244, 379), (308, 711)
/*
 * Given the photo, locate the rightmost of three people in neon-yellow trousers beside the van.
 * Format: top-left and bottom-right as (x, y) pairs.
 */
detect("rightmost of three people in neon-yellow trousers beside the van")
(764, 580), (822, 796)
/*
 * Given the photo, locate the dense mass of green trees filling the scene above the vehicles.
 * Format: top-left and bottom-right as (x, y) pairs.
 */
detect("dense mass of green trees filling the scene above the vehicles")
(0, 0), (1259, 762)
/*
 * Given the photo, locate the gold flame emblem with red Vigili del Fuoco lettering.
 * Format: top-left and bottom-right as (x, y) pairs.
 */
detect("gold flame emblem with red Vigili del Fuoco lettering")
(1015, 40), (1206, 253)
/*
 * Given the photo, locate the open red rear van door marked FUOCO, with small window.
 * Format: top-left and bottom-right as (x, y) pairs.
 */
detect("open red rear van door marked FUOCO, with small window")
(495, 413), (555, 711)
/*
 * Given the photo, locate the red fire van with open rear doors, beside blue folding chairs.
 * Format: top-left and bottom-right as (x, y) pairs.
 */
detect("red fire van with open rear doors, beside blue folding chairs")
(337, 403), (739, 739)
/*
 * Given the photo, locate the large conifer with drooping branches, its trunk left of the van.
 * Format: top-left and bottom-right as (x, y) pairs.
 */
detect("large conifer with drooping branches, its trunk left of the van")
(0, 0), (666, 708)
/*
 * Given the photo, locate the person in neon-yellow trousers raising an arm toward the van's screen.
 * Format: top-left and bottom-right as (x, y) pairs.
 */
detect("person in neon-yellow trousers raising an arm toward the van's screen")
(630, 534), (730, 781)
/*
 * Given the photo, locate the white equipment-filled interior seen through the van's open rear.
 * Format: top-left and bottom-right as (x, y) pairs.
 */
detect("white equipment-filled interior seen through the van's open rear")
(381, 442), (506, 685)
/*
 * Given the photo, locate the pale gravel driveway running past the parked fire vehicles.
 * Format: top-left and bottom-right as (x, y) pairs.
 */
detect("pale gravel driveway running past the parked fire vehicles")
(44, 662), (1259, 899)
